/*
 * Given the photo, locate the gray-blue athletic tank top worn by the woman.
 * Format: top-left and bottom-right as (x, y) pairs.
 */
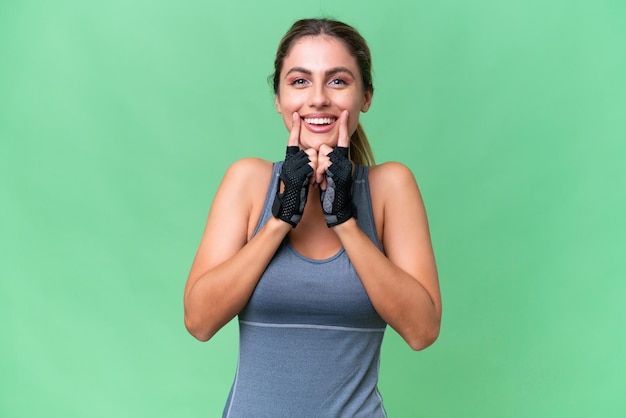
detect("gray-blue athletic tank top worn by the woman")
(223, 162), (386, 418)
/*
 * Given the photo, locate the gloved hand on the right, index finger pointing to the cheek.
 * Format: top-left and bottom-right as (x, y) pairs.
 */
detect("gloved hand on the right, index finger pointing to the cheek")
(315, 110), (356, 228)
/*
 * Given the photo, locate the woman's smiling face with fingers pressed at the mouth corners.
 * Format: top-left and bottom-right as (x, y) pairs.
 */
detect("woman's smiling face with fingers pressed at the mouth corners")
(276, 36), (372, 150)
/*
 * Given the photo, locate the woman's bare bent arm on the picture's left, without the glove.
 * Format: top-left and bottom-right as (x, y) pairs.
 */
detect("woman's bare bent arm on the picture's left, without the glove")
(184, 159), (291, 341)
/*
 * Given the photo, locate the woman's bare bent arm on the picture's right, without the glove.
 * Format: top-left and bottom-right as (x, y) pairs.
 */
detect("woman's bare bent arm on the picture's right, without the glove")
(333, 163), (442, 350)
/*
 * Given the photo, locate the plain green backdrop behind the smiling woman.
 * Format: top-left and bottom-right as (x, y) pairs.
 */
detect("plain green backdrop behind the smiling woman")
(0, 0), (626, 418)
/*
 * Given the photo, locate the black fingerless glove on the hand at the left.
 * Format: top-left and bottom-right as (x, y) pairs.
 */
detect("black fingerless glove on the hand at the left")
(272, 147), (313, 228)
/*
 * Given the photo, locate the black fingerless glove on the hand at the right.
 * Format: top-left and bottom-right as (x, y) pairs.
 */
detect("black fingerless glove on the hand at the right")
(320, 147), (356, 228)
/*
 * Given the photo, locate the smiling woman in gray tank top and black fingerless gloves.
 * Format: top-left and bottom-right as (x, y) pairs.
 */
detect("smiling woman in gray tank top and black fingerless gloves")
(184, 19), (441, 418)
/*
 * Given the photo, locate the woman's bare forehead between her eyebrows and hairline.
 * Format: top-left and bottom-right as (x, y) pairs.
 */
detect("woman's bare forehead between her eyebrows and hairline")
(283, 35), (358, 71)
